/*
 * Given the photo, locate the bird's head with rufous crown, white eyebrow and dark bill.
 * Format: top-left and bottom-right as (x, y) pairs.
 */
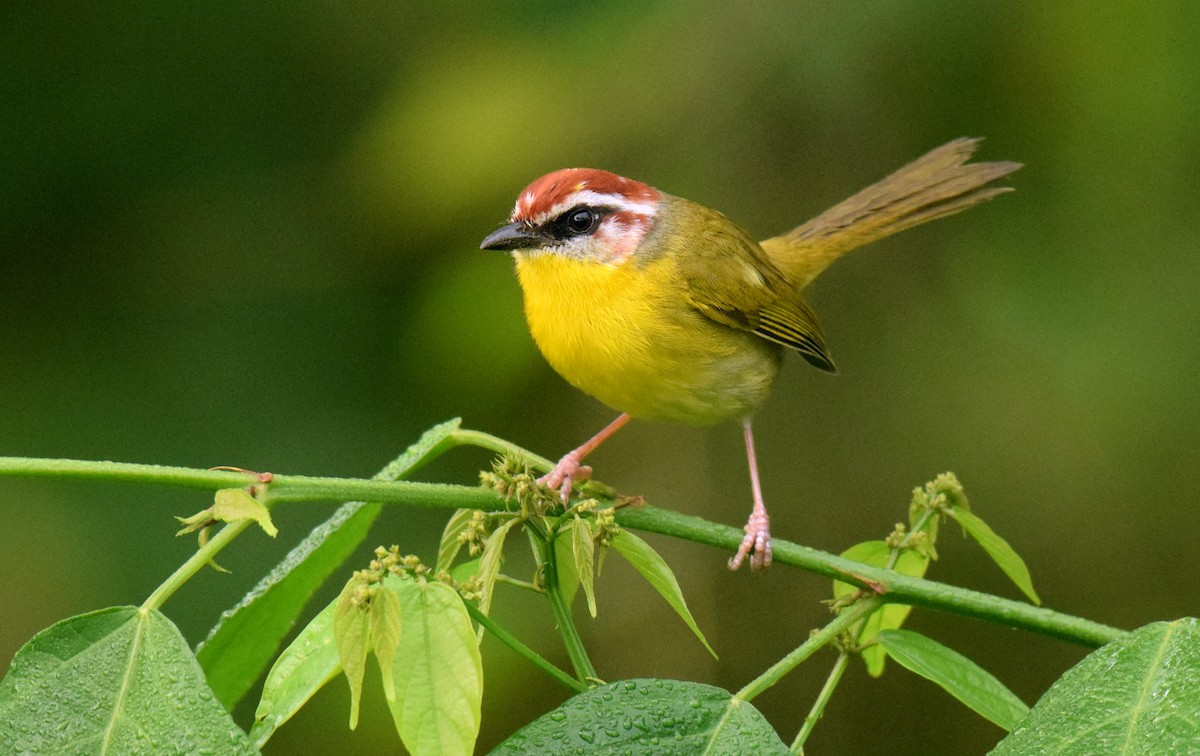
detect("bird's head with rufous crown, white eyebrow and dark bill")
(480, 168), (662, 264)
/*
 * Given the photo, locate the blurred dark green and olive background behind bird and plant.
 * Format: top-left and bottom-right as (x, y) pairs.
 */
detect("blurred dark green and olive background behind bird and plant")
(0, 0), (1200, 754)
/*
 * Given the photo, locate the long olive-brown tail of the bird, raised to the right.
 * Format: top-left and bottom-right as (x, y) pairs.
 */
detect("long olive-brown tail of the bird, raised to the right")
(762, 138), (1021, 288)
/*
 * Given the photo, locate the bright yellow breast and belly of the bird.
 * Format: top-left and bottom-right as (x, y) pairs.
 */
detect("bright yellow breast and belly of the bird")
(516, 253), (781, 425)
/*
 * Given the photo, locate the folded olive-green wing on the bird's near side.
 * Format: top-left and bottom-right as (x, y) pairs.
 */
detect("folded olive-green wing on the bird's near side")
(679, 195), (836, 372)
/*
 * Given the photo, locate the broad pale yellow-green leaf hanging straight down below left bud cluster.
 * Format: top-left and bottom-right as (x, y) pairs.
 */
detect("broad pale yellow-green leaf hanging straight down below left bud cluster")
(384, 577), (484, 756)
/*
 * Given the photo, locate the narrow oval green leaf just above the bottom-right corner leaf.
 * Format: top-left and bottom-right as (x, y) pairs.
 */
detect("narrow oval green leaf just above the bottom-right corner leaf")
(878, 630), (1030, 730)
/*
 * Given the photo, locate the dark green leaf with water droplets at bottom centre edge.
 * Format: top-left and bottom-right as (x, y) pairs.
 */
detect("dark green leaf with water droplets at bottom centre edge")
(493, 679), (787, 756)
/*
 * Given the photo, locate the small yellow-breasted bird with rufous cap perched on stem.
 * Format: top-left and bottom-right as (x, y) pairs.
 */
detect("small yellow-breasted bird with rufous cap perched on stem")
(480, 139), (1021, 570)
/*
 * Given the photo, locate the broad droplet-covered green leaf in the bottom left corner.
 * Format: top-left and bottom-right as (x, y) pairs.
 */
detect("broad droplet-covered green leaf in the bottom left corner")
(0, 606), (256, 754)
